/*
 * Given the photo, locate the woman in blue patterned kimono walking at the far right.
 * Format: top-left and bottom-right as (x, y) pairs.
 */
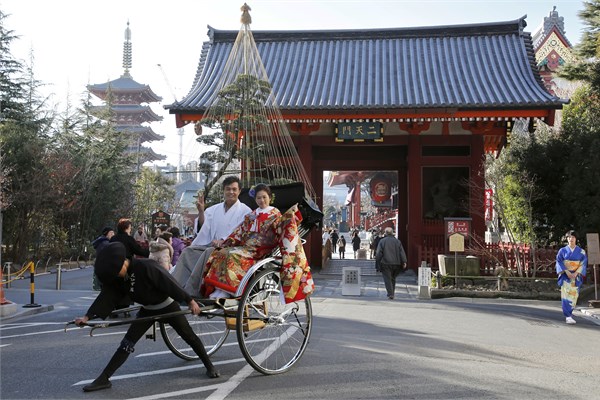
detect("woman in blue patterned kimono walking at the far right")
(556, 231), (587, 324)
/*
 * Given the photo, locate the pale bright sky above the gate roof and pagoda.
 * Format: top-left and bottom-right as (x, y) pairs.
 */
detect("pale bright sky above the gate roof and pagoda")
(0, 0), (584, 165)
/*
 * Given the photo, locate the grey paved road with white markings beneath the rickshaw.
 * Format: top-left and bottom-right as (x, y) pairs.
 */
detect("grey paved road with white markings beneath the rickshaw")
(0, 269), (600, 400)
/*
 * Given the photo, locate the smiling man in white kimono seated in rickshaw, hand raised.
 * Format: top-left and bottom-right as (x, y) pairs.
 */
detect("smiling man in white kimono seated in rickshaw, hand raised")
(173, 176), (252, 297)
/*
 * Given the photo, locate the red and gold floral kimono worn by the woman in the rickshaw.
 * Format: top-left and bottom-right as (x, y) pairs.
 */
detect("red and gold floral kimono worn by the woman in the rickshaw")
(201, 206), (314, 303)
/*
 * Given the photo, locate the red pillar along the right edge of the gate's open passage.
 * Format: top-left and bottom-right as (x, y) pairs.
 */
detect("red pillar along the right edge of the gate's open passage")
(405, 135), (423, 270)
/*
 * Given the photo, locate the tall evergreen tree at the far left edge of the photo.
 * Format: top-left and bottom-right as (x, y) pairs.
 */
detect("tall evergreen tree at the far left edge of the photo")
(0, 12), (53, 260)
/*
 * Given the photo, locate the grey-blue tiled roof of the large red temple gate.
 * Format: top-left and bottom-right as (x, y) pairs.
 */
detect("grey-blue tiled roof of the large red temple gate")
(166, 17), (564, 115)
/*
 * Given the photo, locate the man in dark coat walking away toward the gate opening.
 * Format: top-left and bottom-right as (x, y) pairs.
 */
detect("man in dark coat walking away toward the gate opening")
(375, 226), (406, 300)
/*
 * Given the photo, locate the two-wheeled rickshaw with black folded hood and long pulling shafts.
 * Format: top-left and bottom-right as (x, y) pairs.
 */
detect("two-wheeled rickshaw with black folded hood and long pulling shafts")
(65, 183), (323, 375)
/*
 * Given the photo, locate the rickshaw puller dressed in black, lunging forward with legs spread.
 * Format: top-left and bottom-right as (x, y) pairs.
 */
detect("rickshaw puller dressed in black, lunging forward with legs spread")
(75, 242), (220, 392)
